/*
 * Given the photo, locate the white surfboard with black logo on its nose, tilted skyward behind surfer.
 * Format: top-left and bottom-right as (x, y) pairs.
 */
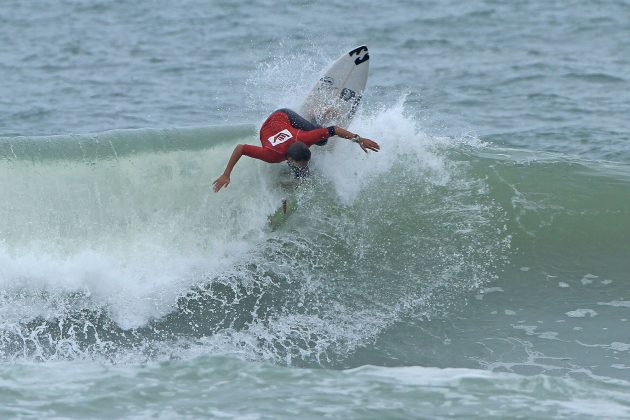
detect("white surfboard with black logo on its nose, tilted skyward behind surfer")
(298, 45), (370, 128)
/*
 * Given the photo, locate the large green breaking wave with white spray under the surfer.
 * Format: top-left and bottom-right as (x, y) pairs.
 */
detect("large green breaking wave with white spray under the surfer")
(0, 105), (630, 367)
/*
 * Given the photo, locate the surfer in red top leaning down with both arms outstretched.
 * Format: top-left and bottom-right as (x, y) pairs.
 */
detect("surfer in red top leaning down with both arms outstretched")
(212, 108), (380, 192)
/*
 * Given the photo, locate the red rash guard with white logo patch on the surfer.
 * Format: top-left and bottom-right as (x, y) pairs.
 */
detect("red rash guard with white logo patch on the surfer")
(243, 112), (333, 163)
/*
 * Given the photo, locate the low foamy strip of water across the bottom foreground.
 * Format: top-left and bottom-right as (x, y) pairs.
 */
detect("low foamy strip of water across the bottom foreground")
(0, 356), (630, 419)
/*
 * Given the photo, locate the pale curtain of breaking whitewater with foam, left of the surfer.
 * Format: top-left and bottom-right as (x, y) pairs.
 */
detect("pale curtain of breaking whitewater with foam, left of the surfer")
(0, 145), (279, 329)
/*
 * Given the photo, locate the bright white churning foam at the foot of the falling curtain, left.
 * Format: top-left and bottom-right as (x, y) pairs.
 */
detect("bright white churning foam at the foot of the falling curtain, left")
(0, 240), (247, 329)
